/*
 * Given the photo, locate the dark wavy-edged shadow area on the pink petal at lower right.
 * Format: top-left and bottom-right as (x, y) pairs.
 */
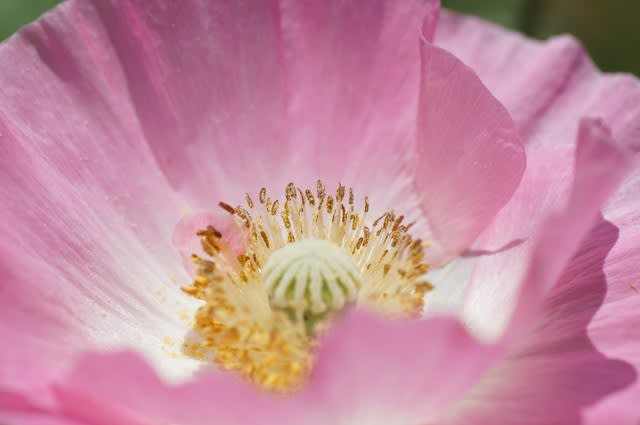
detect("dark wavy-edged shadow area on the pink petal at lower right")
(456, 217), (637, 425)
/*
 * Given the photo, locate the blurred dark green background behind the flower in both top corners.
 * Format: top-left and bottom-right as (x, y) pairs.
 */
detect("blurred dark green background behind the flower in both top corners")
(0, 0), (640, 75)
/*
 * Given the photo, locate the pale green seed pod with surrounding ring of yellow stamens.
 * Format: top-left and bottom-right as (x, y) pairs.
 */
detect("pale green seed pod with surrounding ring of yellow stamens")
(183, 181), (431, 391)
